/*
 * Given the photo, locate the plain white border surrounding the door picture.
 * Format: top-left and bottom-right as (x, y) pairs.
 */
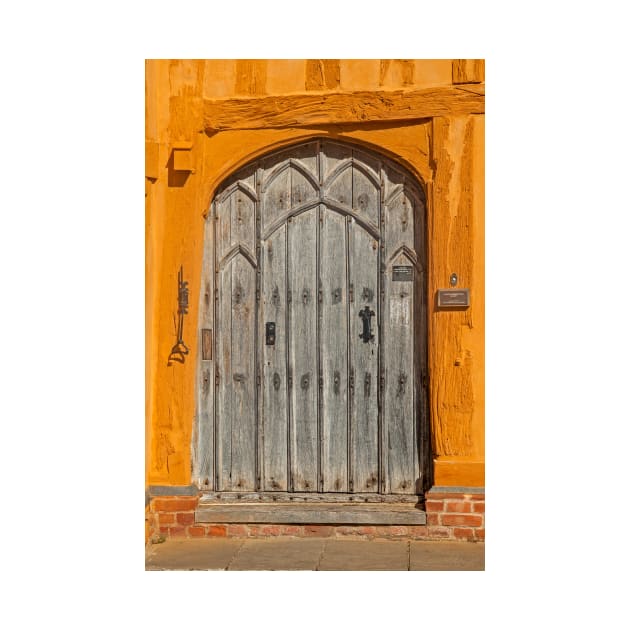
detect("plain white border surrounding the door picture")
(0, 1), (630, 629)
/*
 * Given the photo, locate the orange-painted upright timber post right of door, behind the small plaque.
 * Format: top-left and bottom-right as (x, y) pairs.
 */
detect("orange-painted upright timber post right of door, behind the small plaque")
(429, 116), (482, 456)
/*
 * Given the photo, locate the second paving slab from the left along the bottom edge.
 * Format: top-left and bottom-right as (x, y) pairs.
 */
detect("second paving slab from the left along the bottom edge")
(228, 539), (325, 571)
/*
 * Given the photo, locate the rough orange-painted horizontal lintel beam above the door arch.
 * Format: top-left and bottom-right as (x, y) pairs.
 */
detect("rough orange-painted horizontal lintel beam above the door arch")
(204, 85), (485, 132)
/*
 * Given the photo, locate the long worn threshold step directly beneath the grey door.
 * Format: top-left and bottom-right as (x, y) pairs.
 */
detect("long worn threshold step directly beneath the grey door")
(195, 500), (427, 525)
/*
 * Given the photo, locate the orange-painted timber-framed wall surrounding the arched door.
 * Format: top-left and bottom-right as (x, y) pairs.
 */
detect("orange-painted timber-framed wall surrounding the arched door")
(145, 59), (484, 486)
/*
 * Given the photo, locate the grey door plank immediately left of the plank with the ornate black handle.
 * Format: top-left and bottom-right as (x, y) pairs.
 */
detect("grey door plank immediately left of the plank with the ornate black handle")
(320, 207), (348, 492)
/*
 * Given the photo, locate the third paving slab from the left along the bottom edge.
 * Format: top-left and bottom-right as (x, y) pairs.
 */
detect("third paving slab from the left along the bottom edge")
(319, 540), (409, 571)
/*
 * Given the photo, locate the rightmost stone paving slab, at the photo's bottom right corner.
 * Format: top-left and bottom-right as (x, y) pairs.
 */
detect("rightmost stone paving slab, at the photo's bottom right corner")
(409, 540), (485, 571)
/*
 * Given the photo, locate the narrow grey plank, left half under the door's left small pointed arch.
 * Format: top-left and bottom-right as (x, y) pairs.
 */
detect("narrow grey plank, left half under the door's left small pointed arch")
(215, 260), (234, 490)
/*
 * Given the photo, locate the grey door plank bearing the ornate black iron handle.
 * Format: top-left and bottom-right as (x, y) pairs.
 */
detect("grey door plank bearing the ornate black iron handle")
(349, 222), (381, 492)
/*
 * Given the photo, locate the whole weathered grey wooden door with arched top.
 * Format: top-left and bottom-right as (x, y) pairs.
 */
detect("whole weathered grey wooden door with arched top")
(196, 140), (426, 500)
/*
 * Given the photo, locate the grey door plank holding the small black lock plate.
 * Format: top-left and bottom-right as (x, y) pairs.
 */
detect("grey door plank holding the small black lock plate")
(259, 224), (288, 491)
